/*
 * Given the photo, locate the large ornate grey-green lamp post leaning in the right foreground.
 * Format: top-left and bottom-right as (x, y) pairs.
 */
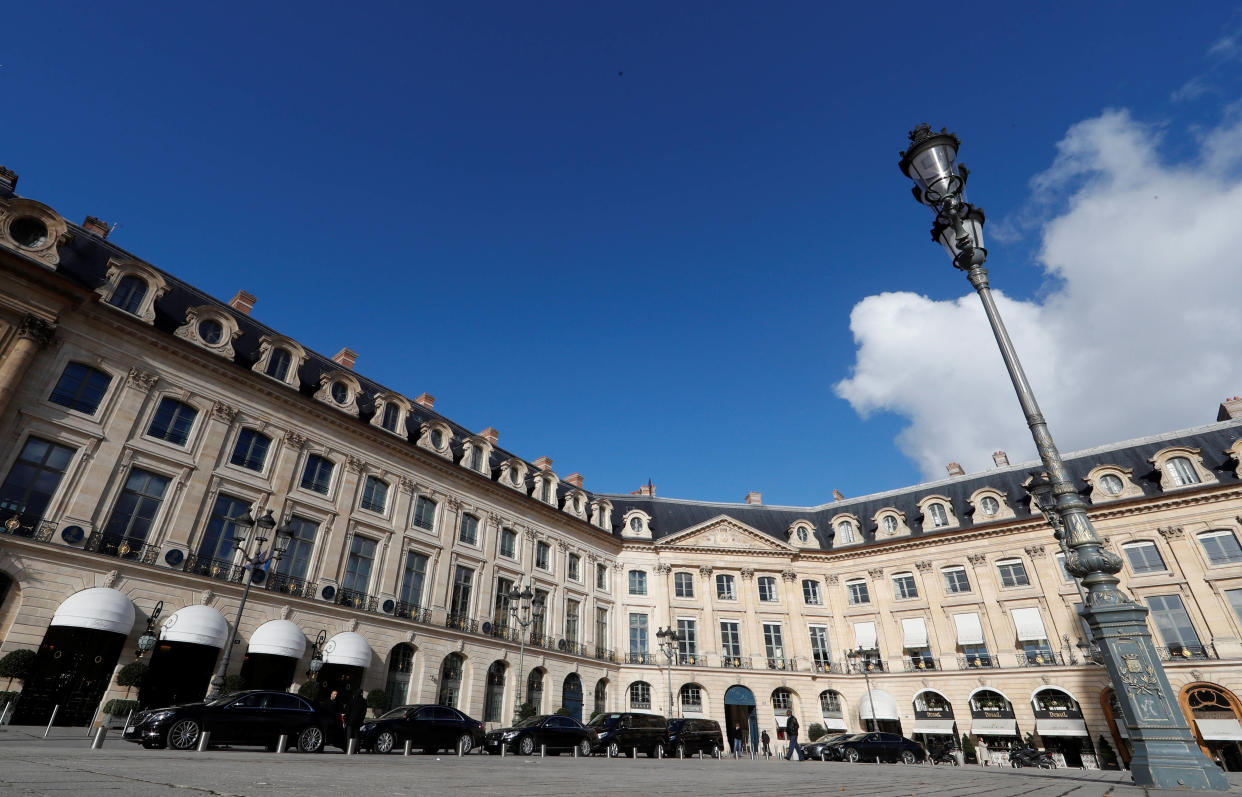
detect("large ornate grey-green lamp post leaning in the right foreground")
(898, 124), (1228, 790)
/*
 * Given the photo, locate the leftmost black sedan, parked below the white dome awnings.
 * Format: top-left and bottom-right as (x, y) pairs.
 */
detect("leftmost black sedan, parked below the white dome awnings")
(124, 691), (344, 752)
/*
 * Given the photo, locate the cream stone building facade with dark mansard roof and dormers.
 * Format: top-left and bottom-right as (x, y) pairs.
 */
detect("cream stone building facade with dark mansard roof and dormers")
(0, 163), (1242, 768)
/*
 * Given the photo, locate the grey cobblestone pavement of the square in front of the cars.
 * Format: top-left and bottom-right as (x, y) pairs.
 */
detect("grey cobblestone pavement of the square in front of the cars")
(0, 727), (1242, 797)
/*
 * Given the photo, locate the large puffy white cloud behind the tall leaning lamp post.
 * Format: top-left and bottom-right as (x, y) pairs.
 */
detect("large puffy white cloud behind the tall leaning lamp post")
(836, 110), (1242, 478)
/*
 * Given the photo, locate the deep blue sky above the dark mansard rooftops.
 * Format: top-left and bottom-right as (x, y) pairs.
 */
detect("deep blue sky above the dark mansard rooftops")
(0, 2), (1242, 504)
